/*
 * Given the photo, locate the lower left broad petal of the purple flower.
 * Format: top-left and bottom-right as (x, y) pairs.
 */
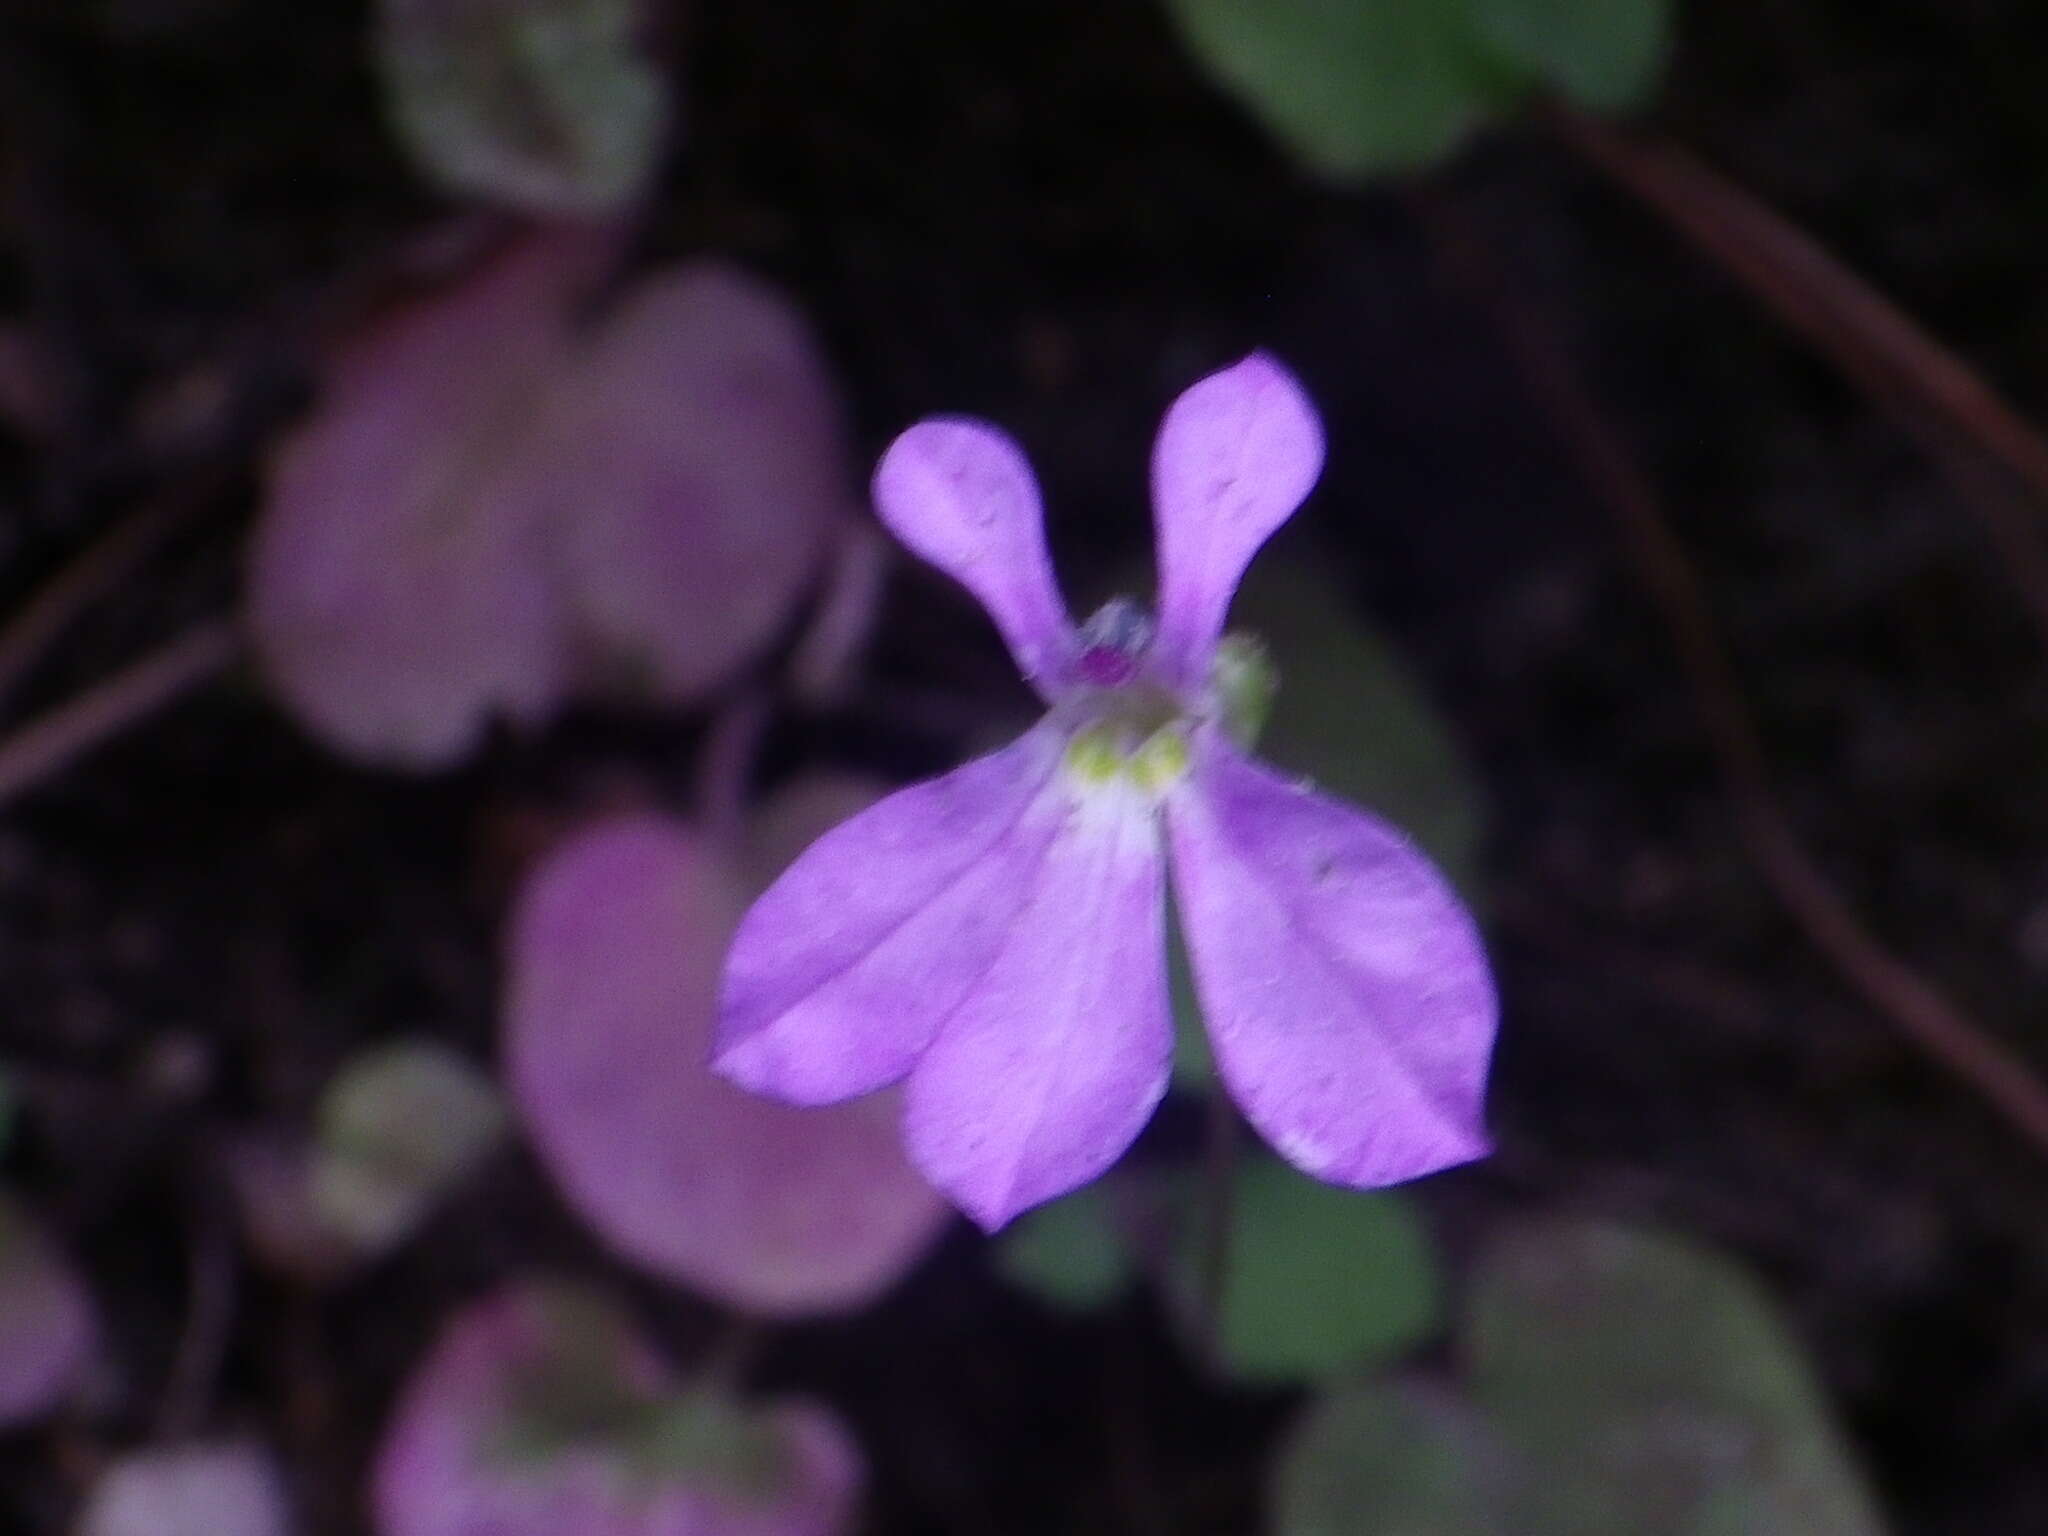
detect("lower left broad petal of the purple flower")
(715, 729), (1063, 1104)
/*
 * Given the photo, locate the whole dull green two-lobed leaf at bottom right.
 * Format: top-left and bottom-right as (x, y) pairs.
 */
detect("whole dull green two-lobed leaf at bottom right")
(1274, 1223), (1882, 1536)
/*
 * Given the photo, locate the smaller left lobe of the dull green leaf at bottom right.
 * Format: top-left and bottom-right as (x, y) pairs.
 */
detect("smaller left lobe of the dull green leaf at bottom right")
(1270, 1380), (1516, 1536)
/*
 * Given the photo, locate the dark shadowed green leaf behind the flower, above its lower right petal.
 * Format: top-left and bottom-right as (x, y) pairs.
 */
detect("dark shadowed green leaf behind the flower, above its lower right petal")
(1231, 559), (1485, 899)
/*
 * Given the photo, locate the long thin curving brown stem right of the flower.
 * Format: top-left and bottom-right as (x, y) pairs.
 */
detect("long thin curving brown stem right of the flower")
(1415, 197), (2048, 1153)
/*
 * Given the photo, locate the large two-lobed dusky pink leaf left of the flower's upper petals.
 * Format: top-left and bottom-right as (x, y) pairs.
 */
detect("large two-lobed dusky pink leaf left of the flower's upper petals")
(250, 236), (848, 768)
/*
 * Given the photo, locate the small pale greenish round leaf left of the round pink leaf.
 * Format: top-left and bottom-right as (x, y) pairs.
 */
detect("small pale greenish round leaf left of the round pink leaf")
(307, 1040), (506, 1253)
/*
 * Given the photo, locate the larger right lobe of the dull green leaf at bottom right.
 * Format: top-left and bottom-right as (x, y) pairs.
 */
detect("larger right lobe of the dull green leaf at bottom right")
(1468, 1223), (1882, 1536)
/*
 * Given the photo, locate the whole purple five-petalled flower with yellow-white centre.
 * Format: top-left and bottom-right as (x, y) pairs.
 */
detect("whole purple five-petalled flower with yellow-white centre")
(715, 352), (1495, 1231)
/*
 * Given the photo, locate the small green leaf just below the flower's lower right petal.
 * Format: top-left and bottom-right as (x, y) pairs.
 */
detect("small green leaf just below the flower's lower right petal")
(1169, 1157), (1440, 1382)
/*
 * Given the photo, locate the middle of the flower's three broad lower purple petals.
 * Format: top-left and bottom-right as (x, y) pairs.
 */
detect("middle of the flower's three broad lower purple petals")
(903, 791), (1174, 1231)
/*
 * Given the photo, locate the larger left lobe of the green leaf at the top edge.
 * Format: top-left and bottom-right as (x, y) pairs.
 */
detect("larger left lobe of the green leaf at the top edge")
(1167, 0), (1520, 180)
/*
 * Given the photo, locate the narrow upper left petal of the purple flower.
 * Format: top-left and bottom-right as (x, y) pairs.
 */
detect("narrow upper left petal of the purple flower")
(874, 416), (1073, 692)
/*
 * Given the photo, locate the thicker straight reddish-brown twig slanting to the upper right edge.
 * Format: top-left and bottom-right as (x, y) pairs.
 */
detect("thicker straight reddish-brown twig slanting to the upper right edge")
(1542, 102), (2048, 651)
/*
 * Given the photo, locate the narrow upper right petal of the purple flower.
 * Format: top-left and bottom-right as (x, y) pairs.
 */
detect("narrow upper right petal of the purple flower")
(1153, 352), (1323, 684)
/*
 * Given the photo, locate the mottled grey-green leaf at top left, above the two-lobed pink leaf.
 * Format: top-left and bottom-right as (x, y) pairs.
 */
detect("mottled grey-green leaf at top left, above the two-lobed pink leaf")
(377, 0), (670, 215)
